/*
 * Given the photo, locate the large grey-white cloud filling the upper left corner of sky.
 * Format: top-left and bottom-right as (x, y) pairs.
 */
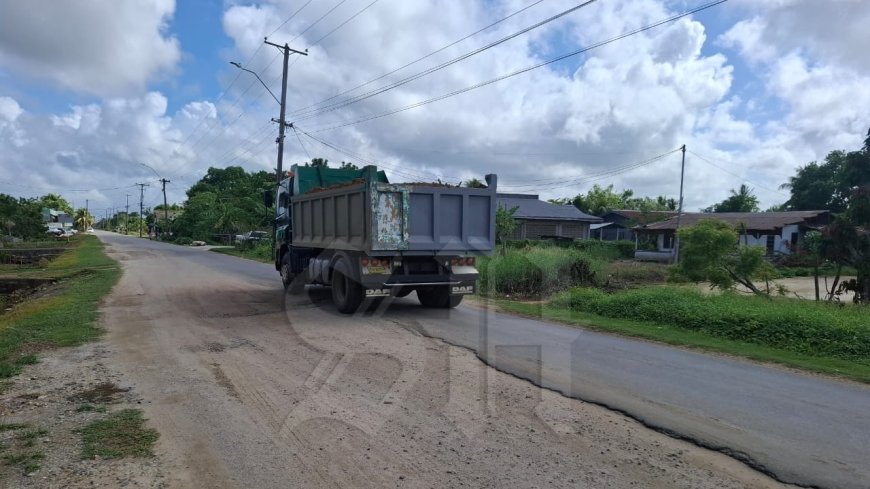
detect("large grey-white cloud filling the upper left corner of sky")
(0, 0), (181, 96)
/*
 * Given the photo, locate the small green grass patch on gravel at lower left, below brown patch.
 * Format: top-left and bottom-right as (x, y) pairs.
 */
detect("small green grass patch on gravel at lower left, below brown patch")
(80, 409), (160, 459)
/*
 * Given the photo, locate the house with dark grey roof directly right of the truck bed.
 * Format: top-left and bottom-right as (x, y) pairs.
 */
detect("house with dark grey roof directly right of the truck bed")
(498, 193), (601, 239)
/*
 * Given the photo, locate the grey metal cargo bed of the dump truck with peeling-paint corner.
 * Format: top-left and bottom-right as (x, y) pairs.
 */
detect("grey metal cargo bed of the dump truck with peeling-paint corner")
(289, 175), (497, 255)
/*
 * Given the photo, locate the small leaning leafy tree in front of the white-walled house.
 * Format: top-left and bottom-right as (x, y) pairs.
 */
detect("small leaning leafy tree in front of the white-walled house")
(673, 219), (773, 295)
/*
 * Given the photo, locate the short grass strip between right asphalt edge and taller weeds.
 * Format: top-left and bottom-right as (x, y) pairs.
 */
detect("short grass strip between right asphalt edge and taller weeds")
(495, 300), (870, 384)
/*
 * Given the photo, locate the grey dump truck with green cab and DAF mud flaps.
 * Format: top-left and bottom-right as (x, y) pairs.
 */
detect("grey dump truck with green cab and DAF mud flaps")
(266, 165), (498, 314)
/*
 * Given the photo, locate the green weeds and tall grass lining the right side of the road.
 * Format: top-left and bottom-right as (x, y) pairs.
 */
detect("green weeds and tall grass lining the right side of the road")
(481, 238), (870, 383)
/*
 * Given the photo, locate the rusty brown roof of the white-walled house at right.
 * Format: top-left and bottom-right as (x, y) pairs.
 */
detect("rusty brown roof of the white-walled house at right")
(635, 211), (830, 231)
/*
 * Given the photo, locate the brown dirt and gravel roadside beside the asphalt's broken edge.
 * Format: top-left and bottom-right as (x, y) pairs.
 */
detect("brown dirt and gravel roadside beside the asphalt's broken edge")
(3, 237), (800, 488)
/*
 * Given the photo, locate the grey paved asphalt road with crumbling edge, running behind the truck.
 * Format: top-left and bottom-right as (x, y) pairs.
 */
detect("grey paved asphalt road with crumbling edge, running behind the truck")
(100, 234), (870, 489)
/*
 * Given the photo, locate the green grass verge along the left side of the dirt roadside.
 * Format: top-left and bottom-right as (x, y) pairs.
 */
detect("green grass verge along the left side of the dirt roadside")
(0, 236), (121, 379)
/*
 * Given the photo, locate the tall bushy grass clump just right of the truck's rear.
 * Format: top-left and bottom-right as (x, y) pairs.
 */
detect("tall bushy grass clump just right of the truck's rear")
(478, 246), (603, 297)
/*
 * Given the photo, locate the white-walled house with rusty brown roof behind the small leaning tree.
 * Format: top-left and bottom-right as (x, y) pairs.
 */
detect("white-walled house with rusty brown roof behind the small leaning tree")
(634, 211), (831, 255)
